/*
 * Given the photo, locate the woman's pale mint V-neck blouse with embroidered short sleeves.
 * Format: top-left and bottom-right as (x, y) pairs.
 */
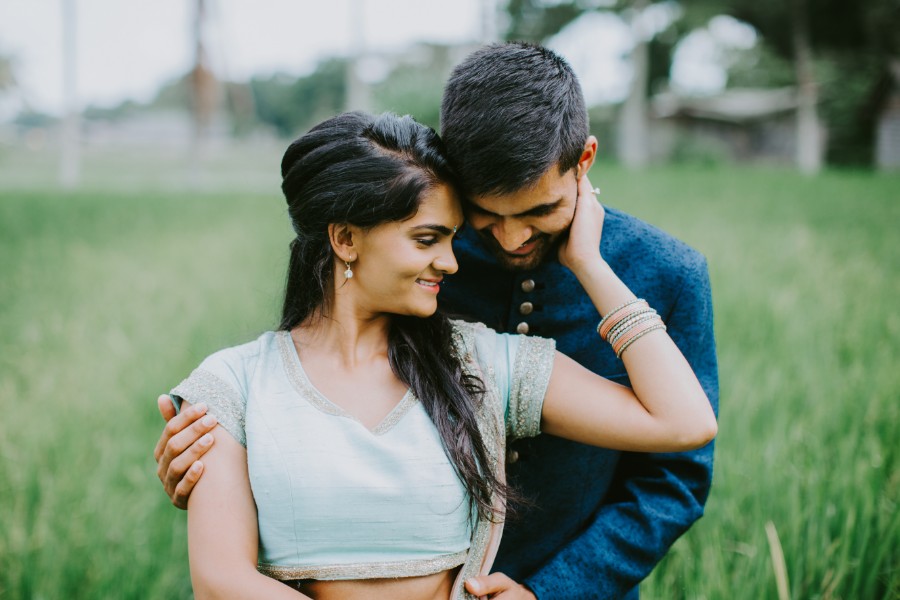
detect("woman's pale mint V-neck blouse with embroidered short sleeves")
(172, 322), (555, 580)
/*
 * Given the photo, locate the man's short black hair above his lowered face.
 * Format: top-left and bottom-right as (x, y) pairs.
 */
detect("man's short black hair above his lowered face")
(441, 42), (588, 196)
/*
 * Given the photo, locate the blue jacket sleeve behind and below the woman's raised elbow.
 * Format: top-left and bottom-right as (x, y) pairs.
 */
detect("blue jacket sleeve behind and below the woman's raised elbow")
(524, 254), (719, 600)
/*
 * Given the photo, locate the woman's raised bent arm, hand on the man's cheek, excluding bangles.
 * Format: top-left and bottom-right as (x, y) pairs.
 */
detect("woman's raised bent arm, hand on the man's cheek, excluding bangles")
(541, 176), (717, 452)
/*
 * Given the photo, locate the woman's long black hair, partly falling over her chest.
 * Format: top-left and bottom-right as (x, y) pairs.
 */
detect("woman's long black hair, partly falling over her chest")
(280, 113), (508, 519)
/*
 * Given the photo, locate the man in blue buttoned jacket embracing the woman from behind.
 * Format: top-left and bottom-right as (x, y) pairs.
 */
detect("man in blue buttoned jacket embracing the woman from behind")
(156, 43), (718, 600)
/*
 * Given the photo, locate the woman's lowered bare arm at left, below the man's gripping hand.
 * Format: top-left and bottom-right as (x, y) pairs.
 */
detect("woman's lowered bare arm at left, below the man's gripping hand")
(188, 412), (308, 600)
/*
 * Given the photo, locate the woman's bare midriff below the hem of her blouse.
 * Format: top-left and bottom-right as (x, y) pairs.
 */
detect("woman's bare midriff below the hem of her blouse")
(291, 567), (459, 600)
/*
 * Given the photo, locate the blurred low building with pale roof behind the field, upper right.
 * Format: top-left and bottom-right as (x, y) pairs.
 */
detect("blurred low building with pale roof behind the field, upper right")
(650, 88), (808, 164)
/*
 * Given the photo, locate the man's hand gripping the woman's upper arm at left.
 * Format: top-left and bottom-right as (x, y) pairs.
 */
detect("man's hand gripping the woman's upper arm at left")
(153, 394), (216, 509)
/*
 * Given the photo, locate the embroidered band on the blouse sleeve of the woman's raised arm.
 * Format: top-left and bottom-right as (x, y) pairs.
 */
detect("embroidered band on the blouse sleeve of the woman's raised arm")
(506, 336), (556, 439)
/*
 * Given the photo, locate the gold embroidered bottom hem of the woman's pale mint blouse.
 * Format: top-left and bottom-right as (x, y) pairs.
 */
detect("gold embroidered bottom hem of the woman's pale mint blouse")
(257, 550), (468, 581)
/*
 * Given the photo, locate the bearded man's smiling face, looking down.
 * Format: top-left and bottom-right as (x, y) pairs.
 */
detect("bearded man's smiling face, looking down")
(466, 165), (578, 271)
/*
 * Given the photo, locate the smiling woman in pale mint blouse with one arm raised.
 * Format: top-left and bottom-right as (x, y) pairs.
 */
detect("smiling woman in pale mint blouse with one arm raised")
(173, 113), (716, 600)
